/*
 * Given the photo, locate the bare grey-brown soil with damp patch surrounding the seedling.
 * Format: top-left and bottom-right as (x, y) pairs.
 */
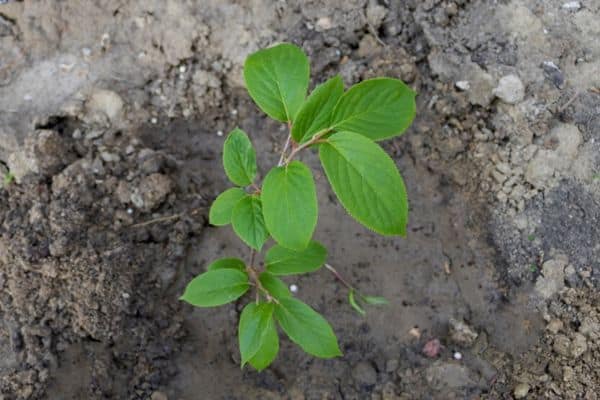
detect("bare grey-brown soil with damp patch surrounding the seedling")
(0, 0), (600, 400)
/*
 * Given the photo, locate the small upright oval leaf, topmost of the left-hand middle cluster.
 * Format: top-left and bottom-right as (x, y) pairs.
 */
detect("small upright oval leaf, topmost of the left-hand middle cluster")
(223, 128), (256, 186)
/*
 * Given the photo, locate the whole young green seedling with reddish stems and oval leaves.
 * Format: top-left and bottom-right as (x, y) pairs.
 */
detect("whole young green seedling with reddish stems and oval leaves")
(181, 44), (415, 371)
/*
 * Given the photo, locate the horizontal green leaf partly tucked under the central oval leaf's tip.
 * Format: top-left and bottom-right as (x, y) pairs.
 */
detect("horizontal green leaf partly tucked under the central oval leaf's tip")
(265, 241), (327, 275)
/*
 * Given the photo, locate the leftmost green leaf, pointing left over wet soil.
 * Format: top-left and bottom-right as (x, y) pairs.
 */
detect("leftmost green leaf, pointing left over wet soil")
(180, 269), (250, 307)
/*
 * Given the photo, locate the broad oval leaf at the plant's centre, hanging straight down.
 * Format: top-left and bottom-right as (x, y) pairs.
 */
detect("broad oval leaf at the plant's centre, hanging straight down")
(261, 161), (318, 250)
